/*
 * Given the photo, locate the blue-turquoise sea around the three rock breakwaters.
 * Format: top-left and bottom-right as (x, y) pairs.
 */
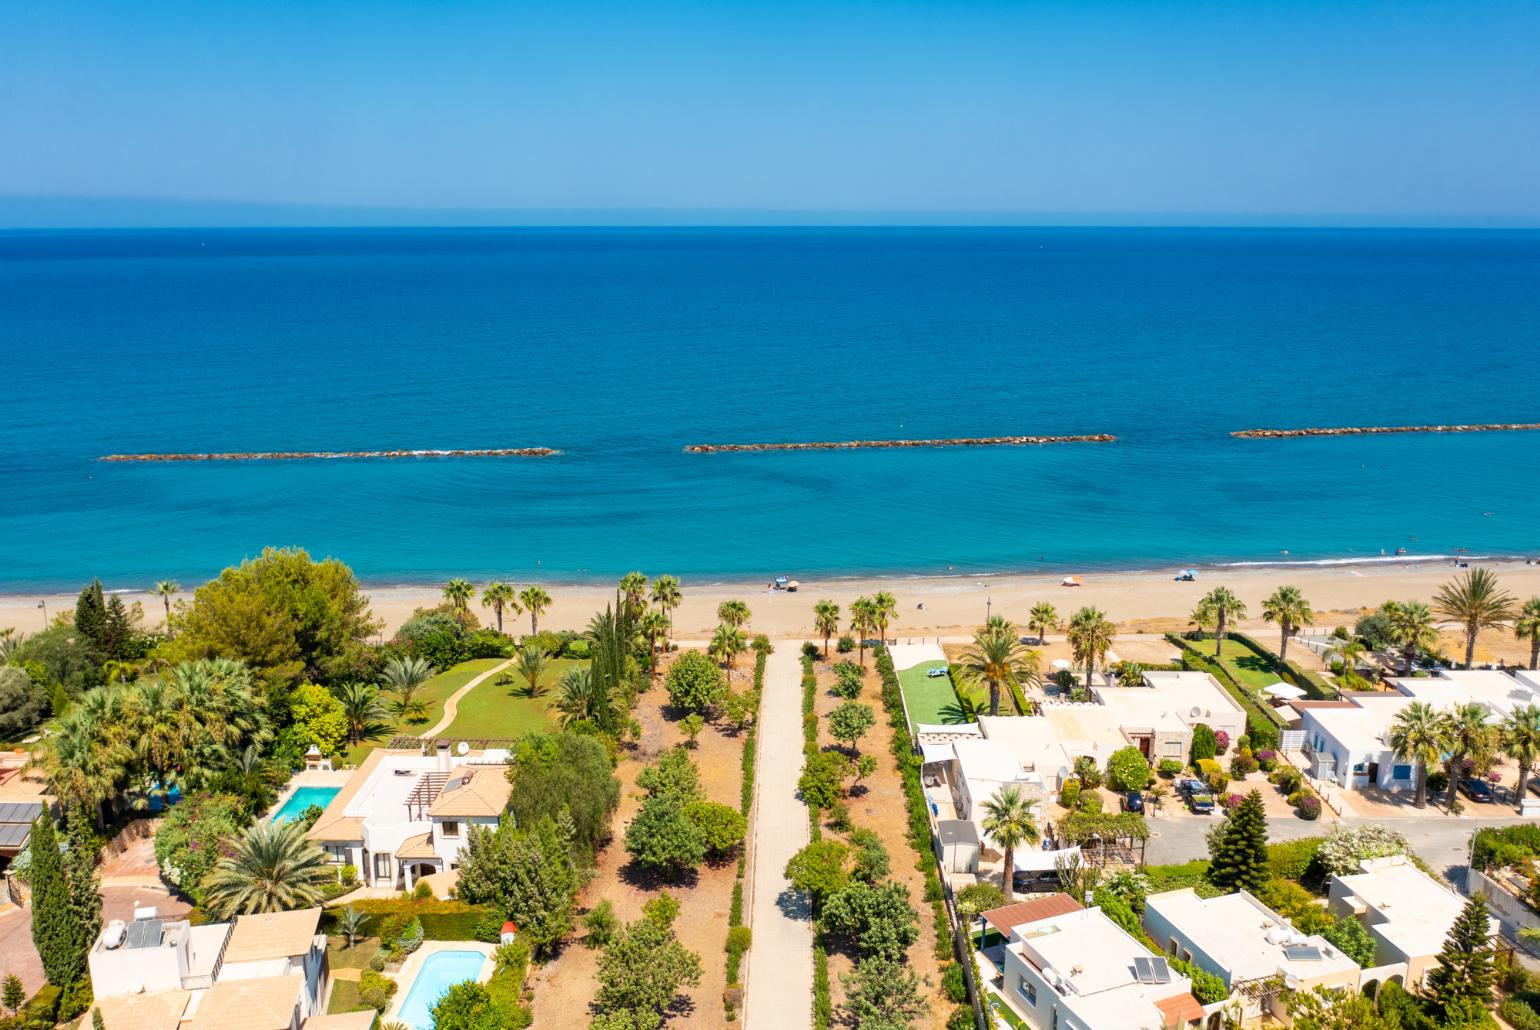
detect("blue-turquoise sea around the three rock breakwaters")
(0, 229), (1540, 590)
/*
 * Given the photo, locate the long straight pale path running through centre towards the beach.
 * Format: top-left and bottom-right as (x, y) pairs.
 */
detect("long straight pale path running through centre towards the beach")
(744, 640), (813, 1030)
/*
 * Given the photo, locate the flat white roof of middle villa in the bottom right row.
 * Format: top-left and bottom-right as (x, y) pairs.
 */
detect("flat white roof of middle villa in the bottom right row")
(1144, 887), (1358, 982)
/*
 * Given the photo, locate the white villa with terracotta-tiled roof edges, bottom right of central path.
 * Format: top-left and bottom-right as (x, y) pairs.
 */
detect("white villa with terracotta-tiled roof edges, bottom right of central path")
(979, 895), (1206, 1030)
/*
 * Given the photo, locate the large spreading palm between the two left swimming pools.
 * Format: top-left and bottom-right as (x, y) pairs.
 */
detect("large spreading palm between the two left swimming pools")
(203, 819), (334, 919)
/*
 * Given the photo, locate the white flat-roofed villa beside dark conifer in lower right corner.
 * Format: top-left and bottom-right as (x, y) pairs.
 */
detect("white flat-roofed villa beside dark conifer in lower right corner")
(1327, 854), (1497, 990)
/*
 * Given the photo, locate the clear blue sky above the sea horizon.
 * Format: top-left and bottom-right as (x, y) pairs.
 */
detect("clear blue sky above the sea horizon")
(0, 0), (1540, 225)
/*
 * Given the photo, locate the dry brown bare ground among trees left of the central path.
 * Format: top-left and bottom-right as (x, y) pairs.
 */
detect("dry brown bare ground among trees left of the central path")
(531, 656), (753, 1030)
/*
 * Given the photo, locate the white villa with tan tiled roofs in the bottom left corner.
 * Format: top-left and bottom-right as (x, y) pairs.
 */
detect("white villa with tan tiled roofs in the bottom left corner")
(85, 908), (352, 1030)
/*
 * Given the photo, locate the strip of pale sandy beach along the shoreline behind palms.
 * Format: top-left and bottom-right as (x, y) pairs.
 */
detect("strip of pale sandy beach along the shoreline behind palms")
(9, 559), (1540, 662)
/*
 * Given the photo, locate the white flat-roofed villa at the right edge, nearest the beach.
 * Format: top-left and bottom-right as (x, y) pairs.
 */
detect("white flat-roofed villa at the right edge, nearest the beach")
(1294, 670), (1540, 790)
